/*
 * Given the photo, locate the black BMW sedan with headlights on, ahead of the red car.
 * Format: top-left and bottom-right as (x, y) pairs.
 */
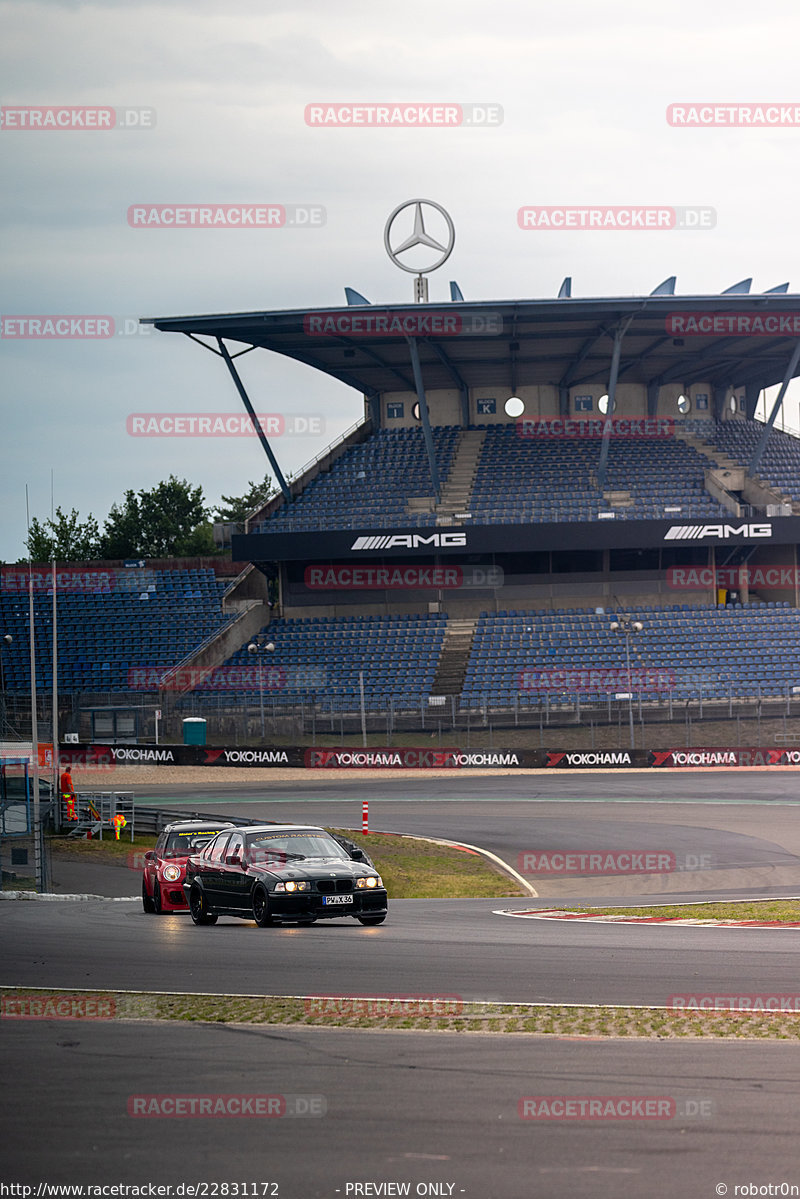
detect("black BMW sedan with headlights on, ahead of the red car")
(184, 824), (387, 928)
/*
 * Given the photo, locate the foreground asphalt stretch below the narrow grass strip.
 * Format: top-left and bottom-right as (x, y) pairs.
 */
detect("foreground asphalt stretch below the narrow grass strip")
(0, 1020), (800, 1199)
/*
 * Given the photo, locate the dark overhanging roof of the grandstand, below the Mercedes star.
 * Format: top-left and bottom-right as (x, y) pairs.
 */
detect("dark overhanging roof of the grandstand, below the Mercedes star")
(144, 292), (800, 394)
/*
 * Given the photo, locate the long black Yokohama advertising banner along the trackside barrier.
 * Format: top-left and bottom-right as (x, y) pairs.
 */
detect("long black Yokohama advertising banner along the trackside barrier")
(60, 745), (800, 771)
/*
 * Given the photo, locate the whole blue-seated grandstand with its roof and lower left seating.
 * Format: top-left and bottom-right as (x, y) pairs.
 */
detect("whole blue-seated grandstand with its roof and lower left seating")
(0, 281), (800, 737)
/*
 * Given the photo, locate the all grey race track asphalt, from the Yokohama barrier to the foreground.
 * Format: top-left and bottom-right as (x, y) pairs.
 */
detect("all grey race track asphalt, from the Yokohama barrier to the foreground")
(6, 771), (800, 1199)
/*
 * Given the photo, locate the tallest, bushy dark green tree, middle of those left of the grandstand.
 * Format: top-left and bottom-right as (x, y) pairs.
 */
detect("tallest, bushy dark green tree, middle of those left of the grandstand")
(101, 475), (209, 558)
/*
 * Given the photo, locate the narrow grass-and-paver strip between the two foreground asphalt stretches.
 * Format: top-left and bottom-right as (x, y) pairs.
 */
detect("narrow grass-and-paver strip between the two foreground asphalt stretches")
(0, 987), (800, 1041)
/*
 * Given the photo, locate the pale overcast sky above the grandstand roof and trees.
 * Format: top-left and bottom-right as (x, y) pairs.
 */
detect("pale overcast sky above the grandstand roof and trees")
(0, 0), (800, 561)
